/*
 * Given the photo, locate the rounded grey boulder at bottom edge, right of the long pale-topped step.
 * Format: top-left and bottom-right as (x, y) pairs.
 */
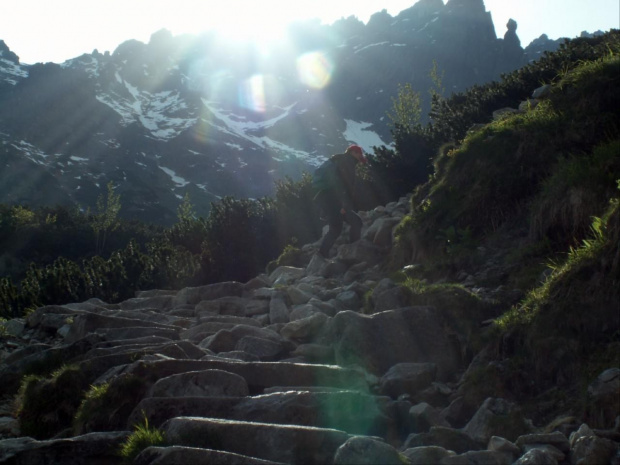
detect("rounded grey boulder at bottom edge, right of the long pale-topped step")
(333, 436), (403, 465)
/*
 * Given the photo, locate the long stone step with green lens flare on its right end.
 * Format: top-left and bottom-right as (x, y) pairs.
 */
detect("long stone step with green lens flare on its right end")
(127, 391), (410, 444)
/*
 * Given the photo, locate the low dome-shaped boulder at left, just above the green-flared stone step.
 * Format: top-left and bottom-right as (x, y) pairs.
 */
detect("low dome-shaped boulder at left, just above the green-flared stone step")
(146, 370), (249, 397)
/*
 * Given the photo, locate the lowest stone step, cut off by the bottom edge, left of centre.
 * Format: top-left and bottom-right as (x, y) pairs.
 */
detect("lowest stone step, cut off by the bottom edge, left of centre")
(133, 446), (284, 465)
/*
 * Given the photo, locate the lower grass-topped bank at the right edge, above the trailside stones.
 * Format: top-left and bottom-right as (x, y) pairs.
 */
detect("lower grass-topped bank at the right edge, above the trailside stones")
(496, 192), (620, 396)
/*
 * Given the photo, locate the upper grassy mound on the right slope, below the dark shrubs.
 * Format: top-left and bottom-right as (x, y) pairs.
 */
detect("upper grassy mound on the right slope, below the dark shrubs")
(404, 49), (620, 262)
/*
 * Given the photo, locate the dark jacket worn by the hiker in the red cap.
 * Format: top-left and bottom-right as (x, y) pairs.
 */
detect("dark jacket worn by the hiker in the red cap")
(316, 153), (358, 210)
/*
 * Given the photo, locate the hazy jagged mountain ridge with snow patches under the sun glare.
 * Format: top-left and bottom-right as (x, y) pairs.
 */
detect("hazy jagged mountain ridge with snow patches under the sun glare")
(0, 0), (580, 225)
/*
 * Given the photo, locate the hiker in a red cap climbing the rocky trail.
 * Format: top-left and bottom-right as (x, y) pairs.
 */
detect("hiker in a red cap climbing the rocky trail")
(312, 145), (367, 258)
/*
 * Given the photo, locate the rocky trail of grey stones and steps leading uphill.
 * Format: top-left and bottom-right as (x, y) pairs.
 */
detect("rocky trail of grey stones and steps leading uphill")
(0, 194), (620, 465)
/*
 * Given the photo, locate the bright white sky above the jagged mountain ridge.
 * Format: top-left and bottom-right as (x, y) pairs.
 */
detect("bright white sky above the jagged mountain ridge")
(0, 0), (620, 64)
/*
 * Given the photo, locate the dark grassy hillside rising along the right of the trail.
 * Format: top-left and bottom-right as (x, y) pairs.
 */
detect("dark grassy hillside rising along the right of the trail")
(393, 32), (620, 427)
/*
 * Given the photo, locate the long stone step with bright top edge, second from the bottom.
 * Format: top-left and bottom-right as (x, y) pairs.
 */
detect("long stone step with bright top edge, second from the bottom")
(161, 417), (350, 465)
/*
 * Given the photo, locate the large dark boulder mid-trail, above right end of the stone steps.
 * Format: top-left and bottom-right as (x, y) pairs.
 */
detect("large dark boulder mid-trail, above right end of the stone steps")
(325, 307), (461, 381)
